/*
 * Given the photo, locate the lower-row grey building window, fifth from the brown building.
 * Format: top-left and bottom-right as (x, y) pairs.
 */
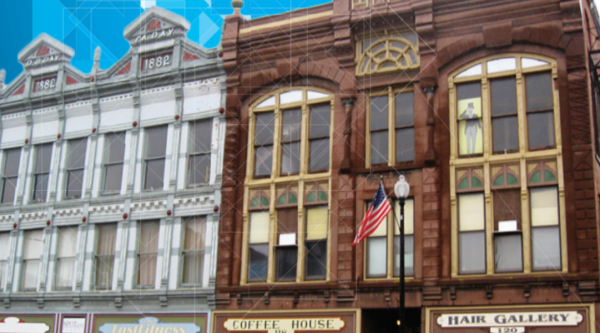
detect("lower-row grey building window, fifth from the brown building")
(21, 229), (44, 291)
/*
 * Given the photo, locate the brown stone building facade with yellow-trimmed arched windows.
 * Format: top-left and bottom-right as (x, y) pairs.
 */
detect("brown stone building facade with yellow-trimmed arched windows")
(213, 0), (600, 333)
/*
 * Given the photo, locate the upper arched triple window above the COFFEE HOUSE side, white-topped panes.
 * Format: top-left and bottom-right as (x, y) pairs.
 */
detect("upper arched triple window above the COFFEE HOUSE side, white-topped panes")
(247, 88), (333, 178)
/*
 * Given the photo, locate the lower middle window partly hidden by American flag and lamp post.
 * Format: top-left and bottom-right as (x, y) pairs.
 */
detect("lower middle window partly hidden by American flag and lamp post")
(365, 198), (415, 279)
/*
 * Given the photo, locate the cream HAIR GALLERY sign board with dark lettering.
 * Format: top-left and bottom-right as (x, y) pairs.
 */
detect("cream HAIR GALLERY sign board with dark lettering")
(437, 311), (583, 333)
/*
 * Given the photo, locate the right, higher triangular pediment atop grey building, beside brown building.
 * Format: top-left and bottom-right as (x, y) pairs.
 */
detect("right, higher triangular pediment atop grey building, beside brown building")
(123, 7), (190, 45)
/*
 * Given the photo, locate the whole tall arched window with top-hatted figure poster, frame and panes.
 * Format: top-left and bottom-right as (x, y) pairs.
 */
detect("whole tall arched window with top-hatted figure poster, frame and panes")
(449, 54), (567, 276)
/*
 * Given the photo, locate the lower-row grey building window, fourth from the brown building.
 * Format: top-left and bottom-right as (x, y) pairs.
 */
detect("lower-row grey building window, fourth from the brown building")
(55, 227), (77, 290)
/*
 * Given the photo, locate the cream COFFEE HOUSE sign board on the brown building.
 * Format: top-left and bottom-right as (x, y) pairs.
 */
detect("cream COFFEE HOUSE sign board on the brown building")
(223, 318), (346, 333)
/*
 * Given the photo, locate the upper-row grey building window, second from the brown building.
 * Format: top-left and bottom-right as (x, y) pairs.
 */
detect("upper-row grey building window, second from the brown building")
(144, 126), (167, 190)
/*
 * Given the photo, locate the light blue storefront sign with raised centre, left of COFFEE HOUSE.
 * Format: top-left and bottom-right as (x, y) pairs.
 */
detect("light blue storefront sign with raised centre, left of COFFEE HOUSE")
(98, 317), (201, 333)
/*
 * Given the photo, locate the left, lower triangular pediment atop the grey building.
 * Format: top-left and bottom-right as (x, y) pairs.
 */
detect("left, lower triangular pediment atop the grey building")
(19, 33), (75, 69)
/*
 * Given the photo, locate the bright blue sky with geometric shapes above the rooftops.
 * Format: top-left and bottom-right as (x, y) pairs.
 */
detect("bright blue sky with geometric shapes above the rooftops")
(0, 0), (330, 83)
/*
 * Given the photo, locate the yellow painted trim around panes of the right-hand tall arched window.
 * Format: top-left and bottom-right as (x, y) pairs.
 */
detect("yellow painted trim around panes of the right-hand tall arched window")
(448, 53), (569, 278)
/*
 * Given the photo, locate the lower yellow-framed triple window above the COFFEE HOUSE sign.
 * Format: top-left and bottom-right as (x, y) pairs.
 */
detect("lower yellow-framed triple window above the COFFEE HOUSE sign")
(243, 182), (329, 283)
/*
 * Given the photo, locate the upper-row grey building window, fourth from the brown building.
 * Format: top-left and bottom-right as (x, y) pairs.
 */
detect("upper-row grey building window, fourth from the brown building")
(65, 138), (87, 199)
